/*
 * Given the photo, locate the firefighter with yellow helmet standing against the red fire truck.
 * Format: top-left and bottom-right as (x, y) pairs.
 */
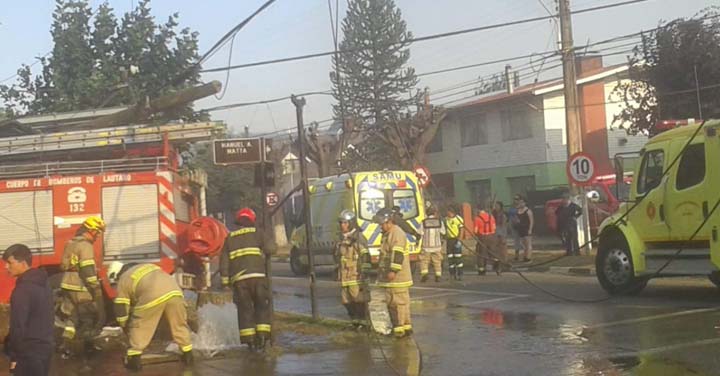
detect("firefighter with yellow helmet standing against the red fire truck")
(60, 216), (106, 356)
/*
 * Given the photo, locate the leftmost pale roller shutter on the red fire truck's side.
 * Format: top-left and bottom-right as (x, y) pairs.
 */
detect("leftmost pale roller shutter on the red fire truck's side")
(0, 190), (53, 252)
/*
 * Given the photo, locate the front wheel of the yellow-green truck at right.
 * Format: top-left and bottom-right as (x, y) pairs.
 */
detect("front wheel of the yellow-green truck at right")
(595, 236), (647, 295)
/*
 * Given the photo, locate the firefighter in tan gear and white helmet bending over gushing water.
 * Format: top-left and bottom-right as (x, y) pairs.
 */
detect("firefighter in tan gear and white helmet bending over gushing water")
(108, 261), (193, 371)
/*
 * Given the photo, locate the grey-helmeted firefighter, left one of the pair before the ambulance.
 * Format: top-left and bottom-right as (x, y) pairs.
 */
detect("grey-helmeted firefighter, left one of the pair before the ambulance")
(335, 210), (372, 329)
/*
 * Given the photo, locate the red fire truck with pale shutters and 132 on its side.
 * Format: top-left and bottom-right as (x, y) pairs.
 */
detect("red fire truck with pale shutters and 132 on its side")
(0, 122), (226, 303)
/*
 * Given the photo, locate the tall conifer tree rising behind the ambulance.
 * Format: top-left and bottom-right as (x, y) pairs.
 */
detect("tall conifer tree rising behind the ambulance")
(330, 0), (417, 129)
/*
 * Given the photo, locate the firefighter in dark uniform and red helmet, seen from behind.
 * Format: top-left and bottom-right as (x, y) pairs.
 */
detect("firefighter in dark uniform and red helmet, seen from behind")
(220, 208), (271, 350)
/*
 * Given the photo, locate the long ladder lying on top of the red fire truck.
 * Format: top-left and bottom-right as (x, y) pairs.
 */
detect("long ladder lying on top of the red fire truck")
(0, 122), (224, 158)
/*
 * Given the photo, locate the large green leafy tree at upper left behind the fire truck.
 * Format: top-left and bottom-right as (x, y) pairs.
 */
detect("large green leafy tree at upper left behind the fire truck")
(0, 0), (199, 118)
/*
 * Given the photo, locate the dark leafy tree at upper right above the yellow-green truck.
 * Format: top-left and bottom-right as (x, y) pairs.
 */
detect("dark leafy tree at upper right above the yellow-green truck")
(613, 7), (720, 134)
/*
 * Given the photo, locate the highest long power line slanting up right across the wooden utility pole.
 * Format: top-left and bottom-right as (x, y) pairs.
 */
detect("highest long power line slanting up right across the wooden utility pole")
(200, 0), (650, 73)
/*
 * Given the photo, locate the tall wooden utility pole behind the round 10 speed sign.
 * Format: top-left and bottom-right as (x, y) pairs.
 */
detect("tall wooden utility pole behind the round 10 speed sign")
(558, 0), (592, 254)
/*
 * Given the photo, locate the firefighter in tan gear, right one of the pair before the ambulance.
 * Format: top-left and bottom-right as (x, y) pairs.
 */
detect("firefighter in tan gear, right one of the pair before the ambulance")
(374, 209), (413, 338)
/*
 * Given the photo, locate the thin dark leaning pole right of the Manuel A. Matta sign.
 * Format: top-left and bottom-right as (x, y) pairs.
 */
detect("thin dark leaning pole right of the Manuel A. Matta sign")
(290, 94), (320, 320)
